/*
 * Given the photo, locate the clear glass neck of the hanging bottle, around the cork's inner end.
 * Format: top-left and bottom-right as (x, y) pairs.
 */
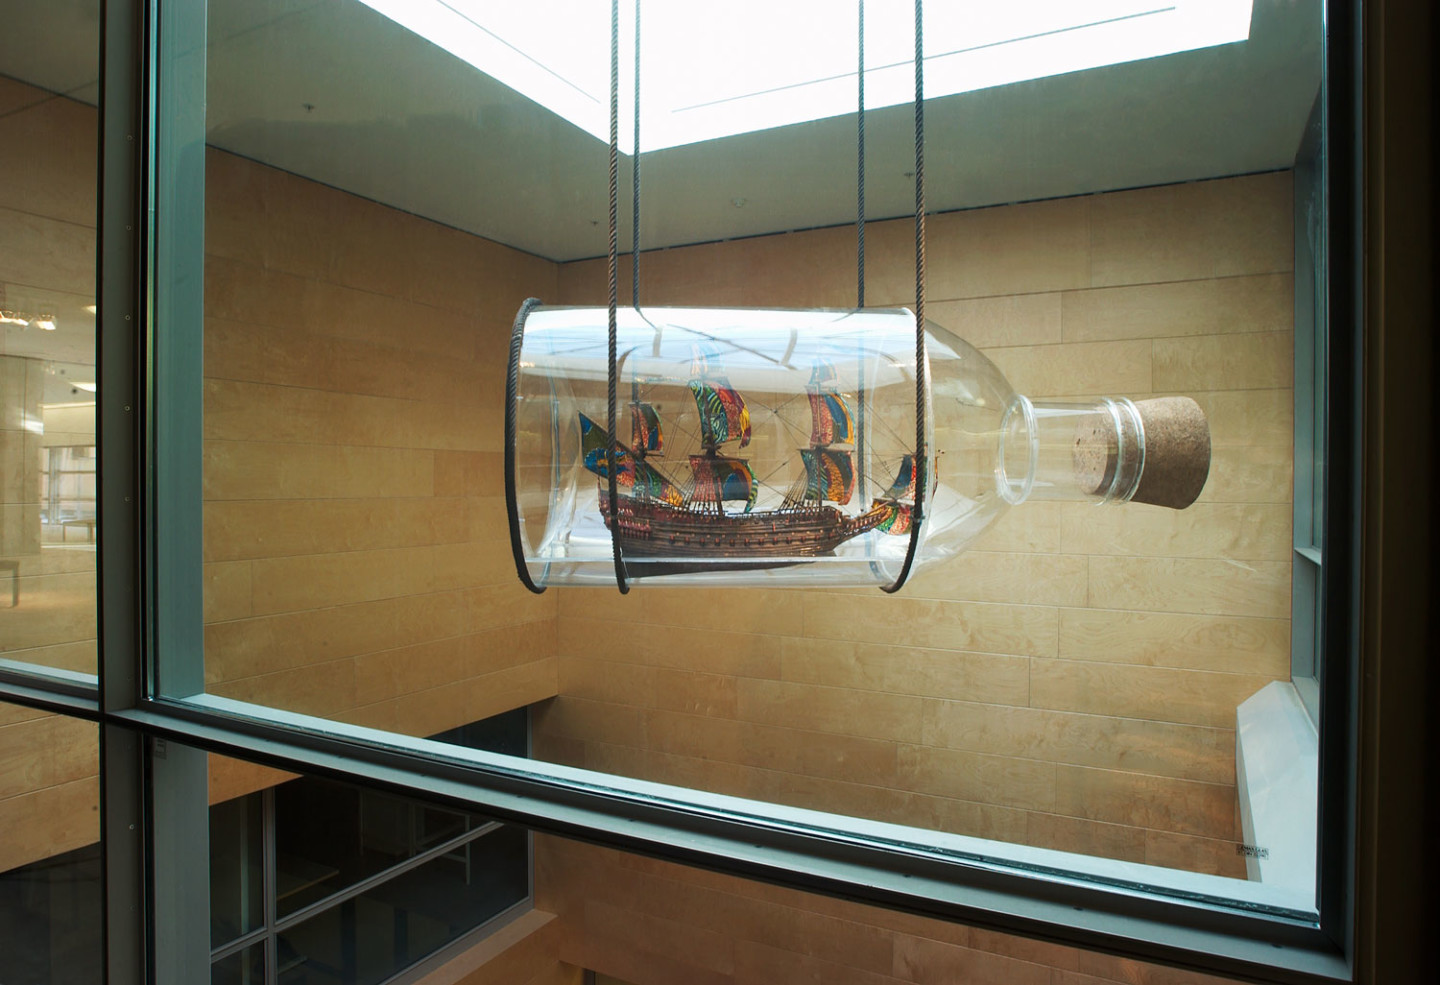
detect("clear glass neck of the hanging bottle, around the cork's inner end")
(995, 396), (1145, 505)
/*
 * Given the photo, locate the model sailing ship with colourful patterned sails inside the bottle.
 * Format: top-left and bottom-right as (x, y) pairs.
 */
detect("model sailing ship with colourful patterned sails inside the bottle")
(579, 354), (916, 573)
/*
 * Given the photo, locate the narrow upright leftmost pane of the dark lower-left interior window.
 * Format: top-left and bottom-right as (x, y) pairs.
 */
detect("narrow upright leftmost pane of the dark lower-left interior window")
(210, 793), (265, 948)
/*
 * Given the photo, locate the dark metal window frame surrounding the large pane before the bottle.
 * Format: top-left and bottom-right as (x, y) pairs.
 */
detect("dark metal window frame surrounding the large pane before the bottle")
(0, 0), (1364, 985)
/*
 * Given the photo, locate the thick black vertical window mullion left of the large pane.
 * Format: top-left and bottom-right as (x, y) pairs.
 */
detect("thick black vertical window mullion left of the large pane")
(95, 0), (153, 985)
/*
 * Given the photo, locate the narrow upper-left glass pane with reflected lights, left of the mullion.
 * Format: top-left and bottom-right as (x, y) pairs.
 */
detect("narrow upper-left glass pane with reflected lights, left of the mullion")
(0, 0), (99, 674)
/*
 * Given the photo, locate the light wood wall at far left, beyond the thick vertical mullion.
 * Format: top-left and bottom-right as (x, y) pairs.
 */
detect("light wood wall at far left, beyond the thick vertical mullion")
(0, 78), (99, 873)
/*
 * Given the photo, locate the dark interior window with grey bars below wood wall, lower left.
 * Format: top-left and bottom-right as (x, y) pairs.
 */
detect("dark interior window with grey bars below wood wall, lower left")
(210, 722), (530, 982)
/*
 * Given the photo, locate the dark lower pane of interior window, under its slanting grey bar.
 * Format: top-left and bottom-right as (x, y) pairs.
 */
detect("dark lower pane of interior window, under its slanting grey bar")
(276, 828), (528, 985)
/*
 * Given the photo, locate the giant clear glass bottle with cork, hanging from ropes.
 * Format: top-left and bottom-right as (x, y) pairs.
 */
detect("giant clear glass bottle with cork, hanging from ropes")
(507, 307), (1210, 589)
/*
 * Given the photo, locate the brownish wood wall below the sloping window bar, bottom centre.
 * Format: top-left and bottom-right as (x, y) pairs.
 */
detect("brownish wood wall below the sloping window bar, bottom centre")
(536, 837), (1230, 985)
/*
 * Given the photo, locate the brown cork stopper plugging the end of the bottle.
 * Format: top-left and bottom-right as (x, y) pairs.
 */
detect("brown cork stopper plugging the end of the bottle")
(1074, 397), (1210, 510)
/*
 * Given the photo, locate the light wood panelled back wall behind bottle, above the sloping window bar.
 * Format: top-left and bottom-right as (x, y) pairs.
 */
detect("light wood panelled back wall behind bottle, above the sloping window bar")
(537, 173), (1293, 875)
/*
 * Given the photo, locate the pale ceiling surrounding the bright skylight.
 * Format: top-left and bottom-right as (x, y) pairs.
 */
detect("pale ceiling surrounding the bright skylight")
(0, 0), (1320, 261)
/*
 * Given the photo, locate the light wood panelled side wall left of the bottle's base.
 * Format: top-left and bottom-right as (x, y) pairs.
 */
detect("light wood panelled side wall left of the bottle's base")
(204, 150), (556, 799)
